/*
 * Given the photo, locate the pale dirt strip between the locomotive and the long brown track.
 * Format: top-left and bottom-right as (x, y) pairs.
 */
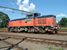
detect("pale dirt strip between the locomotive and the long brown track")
(0, 32), (67, 40)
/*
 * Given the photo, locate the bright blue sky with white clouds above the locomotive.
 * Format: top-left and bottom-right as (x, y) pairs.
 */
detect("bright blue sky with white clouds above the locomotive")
(0, 0), (67, 21)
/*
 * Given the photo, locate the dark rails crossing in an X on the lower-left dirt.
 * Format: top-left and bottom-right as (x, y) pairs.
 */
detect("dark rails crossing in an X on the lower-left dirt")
(0, 37), (27, 50)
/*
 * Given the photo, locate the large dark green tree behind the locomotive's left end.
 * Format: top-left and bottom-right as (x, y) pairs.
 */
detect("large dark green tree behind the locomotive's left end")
(0, 12), (10, 28)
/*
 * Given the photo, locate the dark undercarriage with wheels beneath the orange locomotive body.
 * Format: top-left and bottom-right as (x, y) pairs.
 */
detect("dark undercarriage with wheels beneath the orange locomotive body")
(8, 26), (57, 34)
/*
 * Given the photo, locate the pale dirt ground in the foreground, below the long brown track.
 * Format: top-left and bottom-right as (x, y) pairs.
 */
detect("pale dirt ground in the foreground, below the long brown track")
(0, 39), (67, 50)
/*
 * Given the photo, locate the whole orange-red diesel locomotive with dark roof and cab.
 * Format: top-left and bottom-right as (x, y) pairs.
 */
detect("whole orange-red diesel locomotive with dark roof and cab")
(8, 13), (57, 33)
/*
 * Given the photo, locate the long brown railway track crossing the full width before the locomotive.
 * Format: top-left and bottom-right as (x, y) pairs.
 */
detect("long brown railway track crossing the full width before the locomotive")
(0, 34), (67, 47)
